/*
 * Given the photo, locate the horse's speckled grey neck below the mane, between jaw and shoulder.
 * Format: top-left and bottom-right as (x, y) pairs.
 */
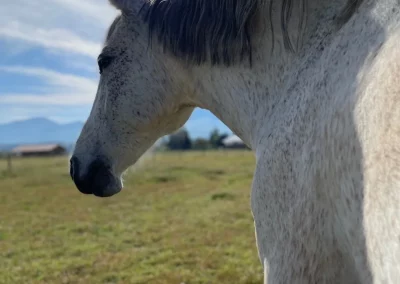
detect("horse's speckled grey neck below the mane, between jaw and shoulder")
(193, 0), (360, 150)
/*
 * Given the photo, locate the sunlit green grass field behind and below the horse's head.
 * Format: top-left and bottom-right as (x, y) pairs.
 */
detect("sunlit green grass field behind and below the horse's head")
(0, 152), (262, 284)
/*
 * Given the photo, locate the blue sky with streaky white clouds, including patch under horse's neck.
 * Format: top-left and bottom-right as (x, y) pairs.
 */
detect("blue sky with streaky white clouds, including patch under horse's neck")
(0, 0), (231, 137)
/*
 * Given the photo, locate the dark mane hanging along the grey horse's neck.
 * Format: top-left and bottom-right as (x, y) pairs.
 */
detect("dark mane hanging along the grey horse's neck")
(141, 0), (363, 66)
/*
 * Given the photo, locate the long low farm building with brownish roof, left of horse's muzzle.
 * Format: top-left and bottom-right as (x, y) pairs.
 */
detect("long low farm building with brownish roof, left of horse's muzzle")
(11, 144), (67, 157)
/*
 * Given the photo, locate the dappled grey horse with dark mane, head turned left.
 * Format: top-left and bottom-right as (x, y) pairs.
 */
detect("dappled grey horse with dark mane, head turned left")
(71, 0), (400, 284)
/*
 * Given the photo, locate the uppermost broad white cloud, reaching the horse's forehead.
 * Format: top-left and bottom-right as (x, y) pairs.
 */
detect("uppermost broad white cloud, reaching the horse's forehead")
(0, 0), (117, 57)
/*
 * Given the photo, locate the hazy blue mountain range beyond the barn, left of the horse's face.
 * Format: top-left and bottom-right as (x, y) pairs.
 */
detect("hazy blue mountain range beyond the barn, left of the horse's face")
(0, 118), (83, 145)
